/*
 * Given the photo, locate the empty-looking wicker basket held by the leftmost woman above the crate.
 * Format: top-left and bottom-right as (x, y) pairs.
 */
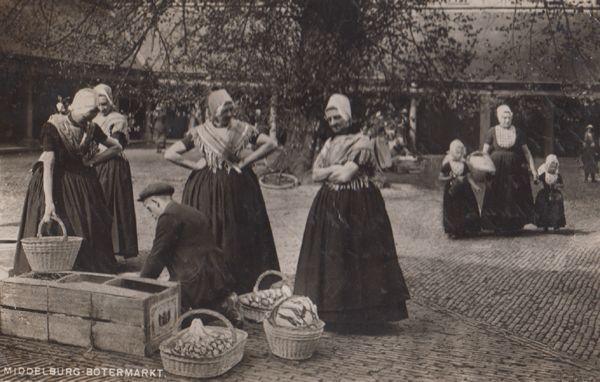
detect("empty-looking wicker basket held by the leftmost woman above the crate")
(21, 216), (83, 272)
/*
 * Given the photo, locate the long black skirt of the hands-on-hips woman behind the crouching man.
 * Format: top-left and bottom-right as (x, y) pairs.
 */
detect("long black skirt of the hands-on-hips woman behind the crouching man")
(182, 167), (279, 293)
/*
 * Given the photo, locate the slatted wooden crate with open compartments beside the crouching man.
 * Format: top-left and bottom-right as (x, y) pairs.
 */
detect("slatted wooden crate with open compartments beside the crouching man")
(0, 272), (181, 355)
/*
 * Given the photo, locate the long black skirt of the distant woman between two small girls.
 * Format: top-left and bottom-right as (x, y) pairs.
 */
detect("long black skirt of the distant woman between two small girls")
(482, 150), (534, 231)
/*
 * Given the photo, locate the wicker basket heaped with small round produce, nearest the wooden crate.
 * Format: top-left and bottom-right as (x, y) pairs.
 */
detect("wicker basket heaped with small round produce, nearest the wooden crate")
(160, 309), (248, 378)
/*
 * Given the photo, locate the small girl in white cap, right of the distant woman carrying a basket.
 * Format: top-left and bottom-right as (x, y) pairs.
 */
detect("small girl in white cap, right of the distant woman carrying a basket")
(534, 154), (566, 231)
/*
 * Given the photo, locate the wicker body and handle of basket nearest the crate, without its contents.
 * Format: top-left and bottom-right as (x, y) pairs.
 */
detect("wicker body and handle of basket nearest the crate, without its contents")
(160, 309), (248, 378)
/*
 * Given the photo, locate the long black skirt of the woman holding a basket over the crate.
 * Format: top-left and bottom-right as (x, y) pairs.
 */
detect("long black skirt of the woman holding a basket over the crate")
(14, 162), (117, 275)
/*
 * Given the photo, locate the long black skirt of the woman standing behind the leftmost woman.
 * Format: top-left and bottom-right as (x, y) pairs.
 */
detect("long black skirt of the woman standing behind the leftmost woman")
(96, 157), (138, 258)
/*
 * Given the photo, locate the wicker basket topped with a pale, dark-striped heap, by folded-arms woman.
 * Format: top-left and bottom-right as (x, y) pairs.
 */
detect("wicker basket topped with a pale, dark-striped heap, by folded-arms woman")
(263, 296), (325, 360)
